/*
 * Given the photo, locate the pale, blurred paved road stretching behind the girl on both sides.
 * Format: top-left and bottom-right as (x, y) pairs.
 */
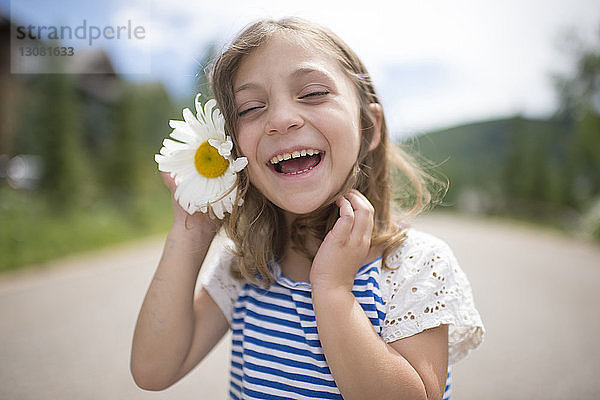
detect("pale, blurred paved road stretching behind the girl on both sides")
(0, 216), (600, 400)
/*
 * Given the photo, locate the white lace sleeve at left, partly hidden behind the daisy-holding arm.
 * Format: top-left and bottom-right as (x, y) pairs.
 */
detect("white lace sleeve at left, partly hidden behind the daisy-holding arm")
(198, 235), (242, 325)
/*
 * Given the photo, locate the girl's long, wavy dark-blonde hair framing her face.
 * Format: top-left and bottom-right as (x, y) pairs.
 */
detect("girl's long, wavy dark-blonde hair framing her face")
(212, 18), (442, 286)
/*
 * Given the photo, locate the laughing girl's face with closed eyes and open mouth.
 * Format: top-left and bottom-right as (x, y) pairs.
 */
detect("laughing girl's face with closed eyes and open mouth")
(234, 34), (361, 214)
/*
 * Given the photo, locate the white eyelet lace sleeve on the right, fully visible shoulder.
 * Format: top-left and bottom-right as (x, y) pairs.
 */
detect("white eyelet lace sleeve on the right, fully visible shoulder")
(381, 229), (485, 364)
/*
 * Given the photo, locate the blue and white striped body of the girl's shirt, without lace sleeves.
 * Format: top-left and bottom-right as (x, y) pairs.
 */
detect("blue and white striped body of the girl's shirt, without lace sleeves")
(229, 263), (385, 399)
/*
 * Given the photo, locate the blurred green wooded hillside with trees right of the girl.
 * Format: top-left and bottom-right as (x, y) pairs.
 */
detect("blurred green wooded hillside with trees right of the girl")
(396, 30), (600, 240)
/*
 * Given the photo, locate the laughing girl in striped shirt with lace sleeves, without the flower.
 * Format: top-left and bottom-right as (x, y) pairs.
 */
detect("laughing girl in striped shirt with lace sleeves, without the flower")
(131, 19), (484, 399)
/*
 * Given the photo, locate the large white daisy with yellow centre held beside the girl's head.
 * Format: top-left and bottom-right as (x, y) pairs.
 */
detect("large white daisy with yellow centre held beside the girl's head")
(154, 95), (248, 219)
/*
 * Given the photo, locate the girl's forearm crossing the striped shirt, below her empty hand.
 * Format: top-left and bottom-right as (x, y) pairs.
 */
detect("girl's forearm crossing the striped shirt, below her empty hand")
(313, 287), (427, 399)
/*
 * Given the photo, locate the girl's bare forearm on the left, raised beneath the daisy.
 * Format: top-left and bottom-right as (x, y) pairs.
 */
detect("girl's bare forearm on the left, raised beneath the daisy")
(131, 224), (214, 388)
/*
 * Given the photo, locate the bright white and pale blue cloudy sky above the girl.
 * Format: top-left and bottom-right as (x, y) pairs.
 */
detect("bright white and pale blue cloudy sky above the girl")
(0, 0), (600, 137)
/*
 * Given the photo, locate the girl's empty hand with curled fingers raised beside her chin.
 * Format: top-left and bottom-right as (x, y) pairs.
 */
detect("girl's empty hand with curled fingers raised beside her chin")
(310, 189), (374, 290)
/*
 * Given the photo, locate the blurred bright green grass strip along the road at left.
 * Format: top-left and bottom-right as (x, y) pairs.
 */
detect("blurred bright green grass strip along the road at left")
(0, 188), (172, 273)
